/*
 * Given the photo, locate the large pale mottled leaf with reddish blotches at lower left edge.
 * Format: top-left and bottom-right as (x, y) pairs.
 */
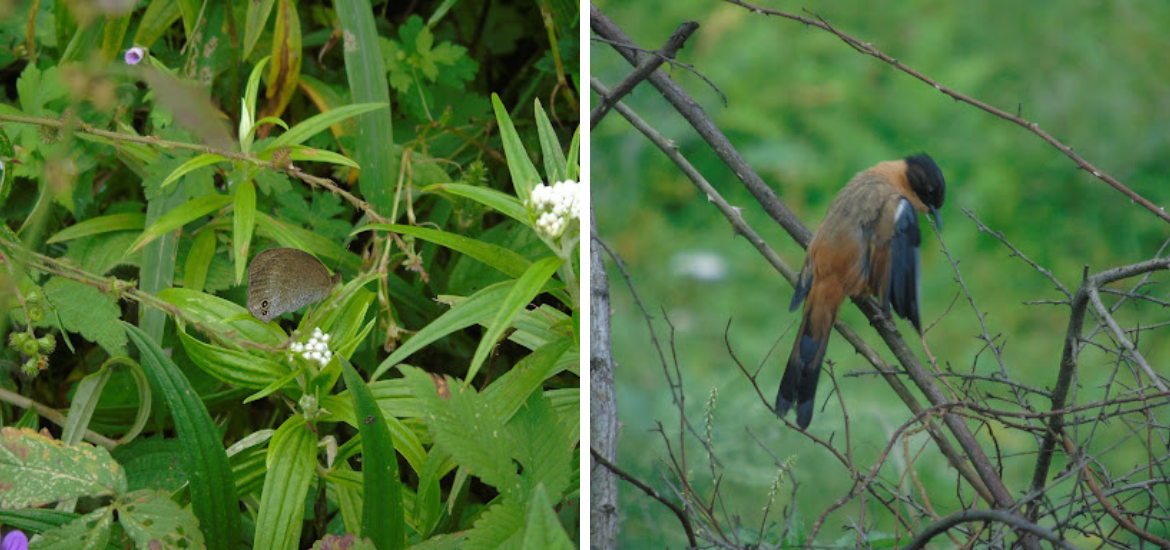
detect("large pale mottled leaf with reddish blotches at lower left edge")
(0, 427), (126, 509)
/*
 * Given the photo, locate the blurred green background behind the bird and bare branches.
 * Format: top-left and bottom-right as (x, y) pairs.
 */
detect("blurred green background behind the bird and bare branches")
(591, 0), (1170, 548)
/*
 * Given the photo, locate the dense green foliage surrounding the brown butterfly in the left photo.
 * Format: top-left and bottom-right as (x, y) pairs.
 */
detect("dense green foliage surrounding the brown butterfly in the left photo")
(0, 0), (581, 549)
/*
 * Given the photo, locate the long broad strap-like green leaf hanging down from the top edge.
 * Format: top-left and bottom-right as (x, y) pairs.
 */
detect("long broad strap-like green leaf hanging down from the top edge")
(333, 0), (401, 216)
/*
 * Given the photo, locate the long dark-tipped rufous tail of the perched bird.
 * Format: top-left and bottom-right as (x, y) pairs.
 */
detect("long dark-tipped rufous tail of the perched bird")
(776, 296), (840, 429)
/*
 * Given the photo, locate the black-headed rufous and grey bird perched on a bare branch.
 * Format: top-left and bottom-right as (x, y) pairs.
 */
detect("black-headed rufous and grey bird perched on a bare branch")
(776, 154), (947, 429)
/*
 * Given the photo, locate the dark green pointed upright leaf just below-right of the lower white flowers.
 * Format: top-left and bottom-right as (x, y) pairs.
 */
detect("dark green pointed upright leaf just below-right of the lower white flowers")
(340, 358), (406, 549)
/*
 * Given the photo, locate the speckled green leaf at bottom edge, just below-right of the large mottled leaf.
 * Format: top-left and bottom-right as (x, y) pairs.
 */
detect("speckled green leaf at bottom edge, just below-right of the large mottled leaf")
(117, 489), (204, 549)
